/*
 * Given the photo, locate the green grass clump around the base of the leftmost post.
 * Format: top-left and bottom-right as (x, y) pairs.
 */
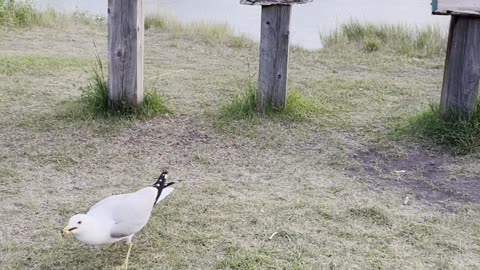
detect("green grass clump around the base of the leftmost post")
(68, 56), (171, 119)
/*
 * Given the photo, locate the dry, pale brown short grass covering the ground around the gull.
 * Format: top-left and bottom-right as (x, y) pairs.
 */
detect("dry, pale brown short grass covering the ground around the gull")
(0, 19), (480, 269)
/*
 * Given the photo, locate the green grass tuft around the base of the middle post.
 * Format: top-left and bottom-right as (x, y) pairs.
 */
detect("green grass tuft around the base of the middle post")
(221, 79), (326, 120)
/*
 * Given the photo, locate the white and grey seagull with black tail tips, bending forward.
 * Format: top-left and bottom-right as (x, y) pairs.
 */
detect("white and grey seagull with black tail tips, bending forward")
(62, 171), (178, 269)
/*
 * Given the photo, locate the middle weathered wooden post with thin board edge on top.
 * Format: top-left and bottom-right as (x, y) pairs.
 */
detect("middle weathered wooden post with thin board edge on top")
(240, 0), (312, 113)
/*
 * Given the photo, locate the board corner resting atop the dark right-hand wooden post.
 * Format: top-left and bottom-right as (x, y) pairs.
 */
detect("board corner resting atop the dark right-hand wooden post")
(432, 0), (480, 16)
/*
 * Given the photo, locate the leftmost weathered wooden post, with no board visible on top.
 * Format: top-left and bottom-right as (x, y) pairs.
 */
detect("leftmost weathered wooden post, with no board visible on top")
(108, 0), (144, 107)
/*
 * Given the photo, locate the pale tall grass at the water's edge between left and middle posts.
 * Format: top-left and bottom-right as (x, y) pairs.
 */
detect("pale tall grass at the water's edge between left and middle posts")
(145, 13), (253, 48)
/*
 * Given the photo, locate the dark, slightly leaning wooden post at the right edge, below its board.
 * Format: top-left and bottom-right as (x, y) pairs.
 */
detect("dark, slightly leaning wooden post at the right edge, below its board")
(440, 16), (480, 116)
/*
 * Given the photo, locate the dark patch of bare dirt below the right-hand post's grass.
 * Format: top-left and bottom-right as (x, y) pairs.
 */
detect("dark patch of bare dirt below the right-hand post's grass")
(347, 149), (480, 210)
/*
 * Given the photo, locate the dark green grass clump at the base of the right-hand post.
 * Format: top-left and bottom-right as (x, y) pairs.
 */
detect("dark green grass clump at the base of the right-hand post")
(403, 104), (480, 155)
